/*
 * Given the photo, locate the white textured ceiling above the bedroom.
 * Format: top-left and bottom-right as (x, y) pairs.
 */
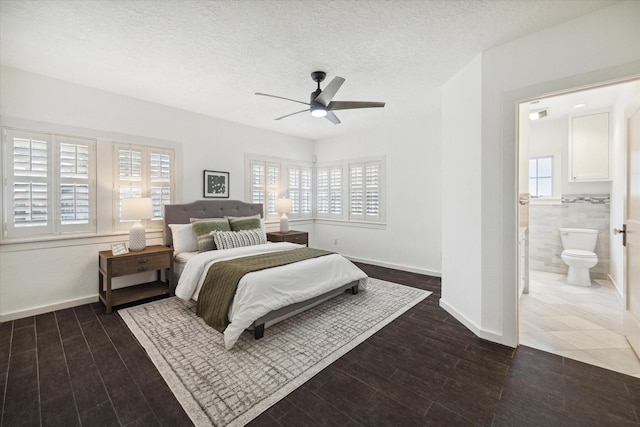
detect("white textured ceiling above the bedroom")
(0, 0), (616, 140)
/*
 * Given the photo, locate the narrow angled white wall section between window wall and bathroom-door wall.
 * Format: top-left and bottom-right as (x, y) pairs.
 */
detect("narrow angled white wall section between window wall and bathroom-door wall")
(440, 56), (482, 333)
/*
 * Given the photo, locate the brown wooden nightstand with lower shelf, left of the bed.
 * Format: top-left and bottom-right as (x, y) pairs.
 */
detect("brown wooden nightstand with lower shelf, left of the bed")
(98, 245), (174, 313)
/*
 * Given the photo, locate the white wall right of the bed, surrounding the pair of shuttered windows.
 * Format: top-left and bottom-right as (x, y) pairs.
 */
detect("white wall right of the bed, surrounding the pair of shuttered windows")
(314, 113), (442, 276)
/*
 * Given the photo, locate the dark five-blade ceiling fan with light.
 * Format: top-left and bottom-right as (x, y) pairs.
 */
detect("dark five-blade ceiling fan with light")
(256, 71), (385, 125)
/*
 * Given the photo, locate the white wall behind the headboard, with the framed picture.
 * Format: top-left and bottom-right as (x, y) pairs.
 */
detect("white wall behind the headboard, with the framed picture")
(0, 68), (313, 321)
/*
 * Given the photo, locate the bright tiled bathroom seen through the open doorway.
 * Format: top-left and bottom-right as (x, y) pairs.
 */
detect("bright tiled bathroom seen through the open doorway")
(519, 81), (640, 376)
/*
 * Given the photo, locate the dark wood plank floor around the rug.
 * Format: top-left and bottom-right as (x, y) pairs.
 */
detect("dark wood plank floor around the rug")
(0, 264), (640, 426)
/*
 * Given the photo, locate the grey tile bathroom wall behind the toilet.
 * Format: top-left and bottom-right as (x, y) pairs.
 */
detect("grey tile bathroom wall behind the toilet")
(529, 194), (610, 279)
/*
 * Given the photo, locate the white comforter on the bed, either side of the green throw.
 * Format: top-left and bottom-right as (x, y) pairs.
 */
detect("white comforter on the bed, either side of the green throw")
(176, 242), (367, 349)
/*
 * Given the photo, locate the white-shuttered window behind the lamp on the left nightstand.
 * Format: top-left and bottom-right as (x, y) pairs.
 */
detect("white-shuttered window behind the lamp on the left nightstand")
(114, 144), (175, 229)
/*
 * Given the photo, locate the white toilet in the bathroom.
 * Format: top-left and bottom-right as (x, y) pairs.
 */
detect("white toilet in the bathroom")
(560, 228), (598, 286)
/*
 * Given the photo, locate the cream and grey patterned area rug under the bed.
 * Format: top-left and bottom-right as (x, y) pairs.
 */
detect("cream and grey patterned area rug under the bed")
(118, 278), (431, 426)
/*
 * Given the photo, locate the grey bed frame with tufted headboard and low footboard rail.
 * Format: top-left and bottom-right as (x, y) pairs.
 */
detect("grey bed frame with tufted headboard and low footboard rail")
(162, 200), (358, 339)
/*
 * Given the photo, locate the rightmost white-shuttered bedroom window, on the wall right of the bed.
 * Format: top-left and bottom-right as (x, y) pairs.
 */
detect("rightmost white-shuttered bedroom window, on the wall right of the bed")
(349, 161), (382, 222)
